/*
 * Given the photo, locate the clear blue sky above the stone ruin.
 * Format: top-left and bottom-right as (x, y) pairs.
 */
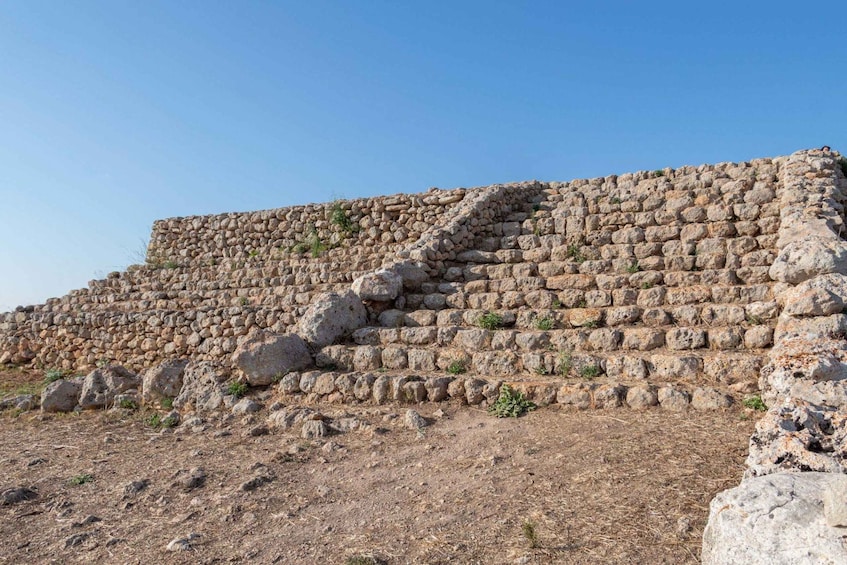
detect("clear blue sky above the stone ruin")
(0, 0), (847, 311)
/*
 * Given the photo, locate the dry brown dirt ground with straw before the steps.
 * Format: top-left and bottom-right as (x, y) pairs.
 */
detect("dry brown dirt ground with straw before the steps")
(0, 373), (757, 565)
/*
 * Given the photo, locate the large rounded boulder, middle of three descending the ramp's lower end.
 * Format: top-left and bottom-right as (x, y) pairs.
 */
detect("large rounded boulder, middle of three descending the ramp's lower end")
(294, 290), (368, 349)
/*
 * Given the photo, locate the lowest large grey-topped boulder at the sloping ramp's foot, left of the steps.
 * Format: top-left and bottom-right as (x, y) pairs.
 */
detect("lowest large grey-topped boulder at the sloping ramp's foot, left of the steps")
(232, 331), (312, 386)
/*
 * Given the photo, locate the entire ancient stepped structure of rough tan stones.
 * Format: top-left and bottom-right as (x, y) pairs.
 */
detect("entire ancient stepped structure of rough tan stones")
(0, 150), (847, 563)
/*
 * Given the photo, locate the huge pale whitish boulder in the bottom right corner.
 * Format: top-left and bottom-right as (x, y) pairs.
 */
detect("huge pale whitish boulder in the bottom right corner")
(702, 473), (847, 565)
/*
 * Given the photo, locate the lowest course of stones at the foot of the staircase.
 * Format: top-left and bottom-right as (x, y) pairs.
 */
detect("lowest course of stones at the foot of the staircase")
(277, 371), (740, 411)
